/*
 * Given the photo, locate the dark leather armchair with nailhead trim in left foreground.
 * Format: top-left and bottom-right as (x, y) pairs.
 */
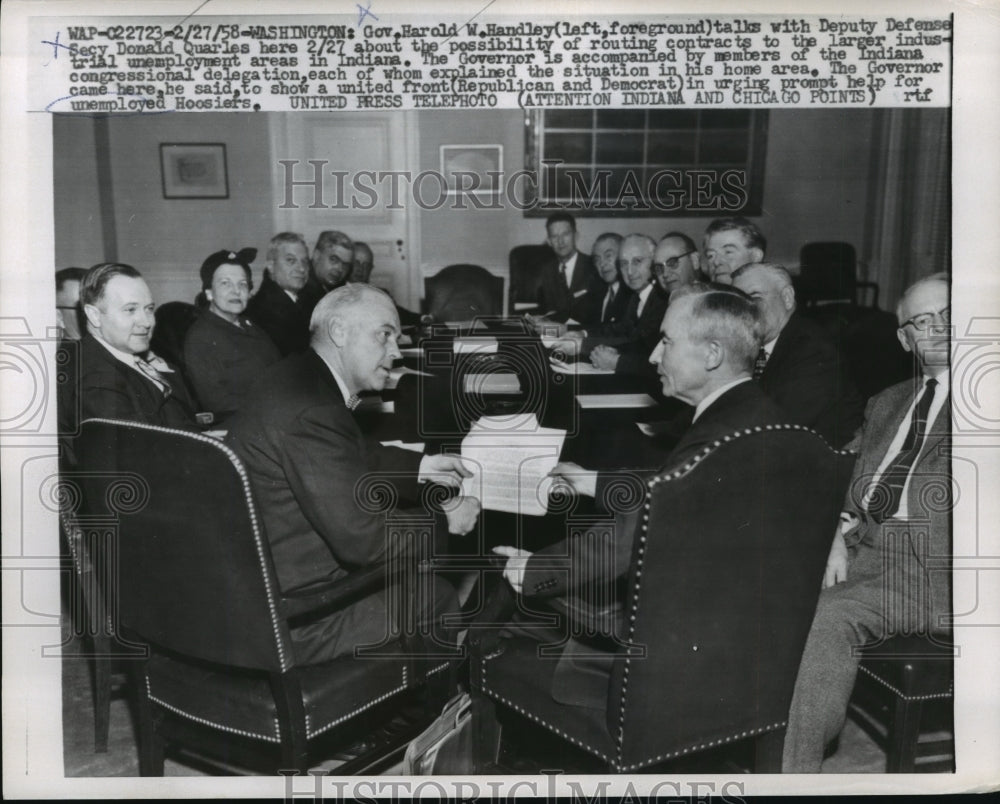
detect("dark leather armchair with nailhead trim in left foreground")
(79, 419), (449, 775)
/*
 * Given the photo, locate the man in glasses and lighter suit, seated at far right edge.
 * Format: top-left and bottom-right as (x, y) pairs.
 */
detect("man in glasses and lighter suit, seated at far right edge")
(782, 274), (952, 773)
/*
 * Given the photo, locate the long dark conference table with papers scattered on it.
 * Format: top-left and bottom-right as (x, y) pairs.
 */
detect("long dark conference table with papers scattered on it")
(356, 318), (690, 554)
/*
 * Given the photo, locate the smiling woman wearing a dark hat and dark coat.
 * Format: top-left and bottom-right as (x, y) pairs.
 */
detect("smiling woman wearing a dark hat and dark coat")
(184, 248), (281, 421)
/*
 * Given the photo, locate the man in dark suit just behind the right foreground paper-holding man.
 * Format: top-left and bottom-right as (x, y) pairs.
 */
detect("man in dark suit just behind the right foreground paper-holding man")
(733, 262), (864, 448)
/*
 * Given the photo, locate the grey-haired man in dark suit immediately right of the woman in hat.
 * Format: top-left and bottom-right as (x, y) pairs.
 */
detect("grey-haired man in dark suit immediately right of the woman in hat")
(247, 232), (315, 355)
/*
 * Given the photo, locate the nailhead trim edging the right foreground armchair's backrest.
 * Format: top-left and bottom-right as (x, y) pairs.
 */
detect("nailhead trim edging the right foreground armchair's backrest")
(612, 424), (849, 771)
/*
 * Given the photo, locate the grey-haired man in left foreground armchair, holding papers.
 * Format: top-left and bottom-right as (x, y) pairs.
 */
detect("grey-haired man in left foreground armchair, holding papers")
(226, 284), (479, 662)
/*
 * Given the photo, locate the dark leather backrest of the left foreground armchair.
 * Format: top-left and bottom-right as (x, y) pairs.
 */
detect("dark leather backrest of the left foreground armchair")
(77, 419), (292, 672)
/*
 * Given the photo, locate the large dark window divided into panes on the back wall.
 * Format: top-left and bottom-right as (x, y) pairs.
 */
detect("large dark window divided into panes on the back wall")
(525, 109), (767, 217)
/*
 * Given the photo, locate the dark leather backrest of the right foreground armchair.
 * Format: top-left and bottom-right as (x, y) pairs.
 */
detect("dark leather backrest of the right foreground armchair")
(608, 425), (853, 770)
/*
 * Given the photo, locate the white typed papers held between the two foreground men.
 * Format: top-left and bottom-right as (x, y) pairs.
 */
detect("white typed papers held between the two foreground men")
(462, 413), (566, 516)
